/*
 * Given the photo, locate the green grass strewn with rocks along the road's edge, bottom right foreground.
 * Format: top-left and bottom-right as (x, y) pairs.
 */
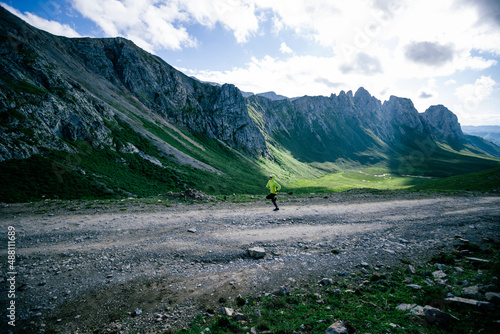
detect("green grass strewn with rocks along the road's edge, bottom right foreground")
(181, 244), (500, 334)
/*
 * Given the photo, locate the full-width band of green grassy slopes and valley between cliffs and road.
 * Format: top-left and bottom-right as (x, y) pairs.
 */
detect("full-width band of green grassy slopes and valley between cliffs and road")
(0, 104), (500, 202)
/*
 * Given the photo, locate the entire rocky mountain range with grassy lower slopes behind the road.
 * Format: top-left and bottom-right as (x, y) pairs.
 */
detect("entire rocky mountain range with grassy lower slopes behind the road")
(0, 8), (500, 201)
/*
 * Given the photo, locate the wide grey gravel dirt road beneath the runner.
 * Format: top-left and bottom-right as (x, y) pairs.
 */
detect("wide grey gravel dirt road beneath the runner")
(0, 194), (500, 333)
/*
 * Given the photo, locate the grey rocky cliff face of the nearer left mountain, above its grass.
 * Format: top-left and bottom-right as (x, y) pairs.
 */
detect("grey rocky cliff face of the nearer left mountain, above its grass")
(0, 8), (266, 161)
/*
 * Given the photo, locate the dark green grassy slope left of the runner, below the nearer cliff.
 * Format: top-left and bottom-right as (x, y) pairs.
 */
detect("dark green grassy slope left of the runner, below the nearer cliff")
(0, 112), (281, 202)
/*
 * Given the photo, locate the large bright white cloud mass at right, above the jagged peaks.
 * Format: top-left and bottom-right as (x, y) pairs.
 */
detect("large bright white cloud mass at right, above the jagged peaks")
(179, 0), (500, 102)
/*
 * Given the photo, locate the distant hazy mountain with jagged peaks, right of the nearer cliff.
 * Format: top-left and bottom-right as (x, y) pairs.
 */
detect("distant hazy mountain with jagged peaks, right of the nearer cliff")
(248, 88), (499, 169)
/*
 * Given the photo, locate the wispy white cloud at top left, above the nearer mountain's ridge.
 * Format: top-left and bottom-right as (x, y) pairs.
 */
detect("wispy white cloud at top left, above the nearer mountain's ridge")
(71, 0), (259, 51)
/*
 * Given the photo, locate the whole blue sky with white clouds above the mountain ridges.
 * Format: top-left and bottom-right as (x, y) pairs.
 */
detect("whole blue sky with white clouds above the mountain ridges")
(0, 0), (500, 125)
